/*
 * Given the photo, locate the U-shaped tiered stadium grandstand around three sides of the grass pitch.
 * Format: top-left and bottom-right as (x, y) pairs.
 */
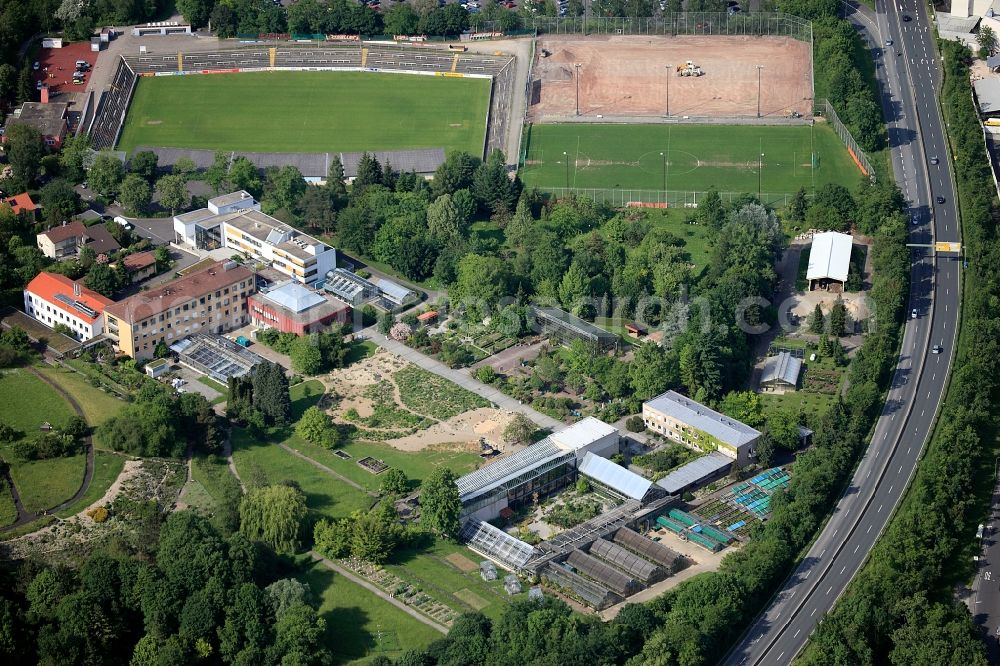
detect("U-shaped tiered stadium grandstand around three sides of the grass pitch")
(90, 43), (515, 154)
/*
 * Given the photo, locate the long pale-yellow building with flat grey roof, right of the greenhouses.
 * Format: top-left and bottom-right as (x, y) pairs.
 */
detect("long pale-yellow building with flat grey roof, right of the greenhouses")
(642, 391), (761, 465)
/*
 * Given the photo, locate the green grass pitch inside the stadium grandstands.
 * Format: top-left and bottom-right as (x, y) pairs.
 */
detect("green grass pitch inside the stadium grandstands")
(118, 72), (490, 155)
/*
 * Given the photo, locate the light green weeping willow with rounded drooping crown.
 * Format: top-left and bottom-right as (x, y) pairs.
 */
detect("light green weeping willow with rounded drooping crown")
(240, 485), (307, 555)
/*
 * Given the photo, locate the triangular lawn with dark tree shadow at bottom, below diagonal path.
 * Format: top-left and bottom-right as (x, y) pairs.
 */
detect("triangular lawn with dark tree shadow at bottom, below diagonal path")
(298, 563), (443, 666)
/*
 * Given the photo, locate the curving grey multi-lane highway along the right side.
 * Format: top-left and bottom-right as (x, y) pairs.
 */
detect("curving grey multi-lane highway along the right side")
(726, 0), (960, 665)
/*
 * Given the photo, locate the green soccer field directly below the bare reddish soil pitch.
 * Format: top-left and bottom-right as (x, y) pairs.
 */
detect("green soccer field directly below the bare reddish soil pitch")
(520, 123), (862, 194)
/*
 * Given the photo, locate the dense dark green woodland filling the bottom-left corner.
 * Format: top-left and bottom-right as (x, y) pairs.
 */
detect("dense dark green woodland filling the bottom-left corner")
(0, 511), (331, 666)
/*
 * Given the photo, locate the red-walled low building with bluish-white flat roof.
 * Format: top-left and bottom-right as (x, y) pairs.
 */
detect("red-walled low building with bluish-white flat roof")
(248, 282), (351, 335)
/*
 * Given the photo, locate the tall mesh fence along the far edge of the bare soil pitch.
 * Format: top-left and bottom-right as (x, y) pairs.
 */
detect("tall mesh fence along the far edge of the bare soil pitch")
(525, 12), (812, 43)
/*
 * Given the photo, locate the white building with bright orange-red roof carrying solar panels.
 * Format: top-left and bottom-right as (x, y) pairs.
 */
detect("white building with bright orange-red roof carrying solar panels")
(24, 271), (114, 341)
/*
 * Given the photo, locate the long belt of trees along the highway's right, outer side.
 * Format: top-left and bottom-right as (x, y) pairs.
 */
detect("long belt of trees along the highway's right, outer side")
(805, 37), (1000, 665)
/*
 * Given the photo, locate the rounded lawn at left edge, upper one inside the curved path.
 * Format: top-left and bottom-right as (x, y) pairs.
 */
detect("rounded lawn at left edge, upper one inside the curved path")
(0, 369), (73, 435)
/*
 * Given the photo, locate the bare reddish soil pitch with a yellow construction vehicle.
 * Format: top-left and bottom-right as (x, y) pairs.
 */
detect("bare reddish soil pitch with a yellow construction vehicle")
(528, 35), (813, 122)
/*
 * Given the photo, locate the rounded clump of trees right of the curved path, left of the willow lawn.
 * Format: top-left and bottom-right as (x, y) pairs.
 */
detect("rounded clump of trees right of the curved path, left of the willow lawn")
(95, 381), (222, 457)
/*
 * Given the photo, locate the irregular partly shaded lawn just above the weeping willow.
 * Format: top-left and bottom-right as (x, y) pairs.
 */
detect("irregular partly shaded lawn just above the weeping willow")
(232, 380), (372, 518)
